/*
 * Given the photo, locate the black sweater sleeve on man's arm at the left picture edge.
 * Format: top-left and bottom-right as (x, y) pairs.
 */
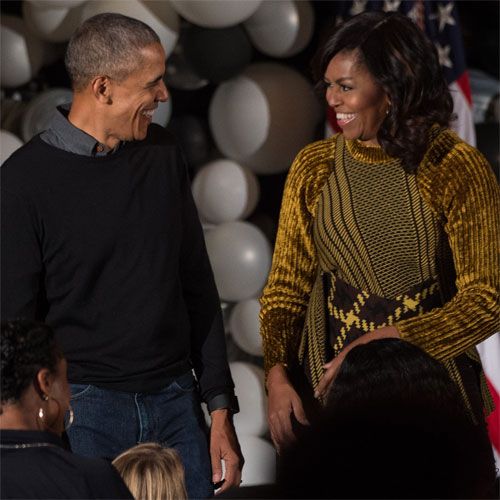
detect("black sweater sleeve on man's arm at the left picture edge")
(1, 186), (43, 321)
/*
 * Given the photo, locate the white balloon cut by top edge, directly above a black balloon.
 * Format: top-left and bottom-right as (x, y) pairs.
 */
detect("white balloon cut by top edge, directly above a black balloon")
(170, 0), (262, 28)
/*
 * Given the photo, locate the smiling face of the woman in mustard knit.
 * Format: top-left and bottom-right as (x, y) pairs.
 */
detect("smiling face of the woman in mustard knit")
(324, 51), (390, 145)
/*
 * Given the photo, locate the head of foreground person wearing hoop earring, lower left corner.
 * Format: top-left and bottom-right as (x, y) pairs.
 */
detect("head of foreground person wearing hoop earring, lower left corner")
(0, 320), (70, 435)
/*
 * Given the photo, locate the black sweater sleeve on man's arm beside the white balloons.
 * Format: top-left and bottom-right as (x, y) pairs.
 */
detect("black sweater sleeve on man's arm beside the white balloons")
(179, 150), (234, 403)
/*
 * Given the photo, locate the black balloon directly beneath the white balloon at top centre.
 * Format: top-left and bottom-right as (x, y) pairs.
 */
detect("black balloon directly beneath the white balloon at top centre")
(183, 26), (252, 83)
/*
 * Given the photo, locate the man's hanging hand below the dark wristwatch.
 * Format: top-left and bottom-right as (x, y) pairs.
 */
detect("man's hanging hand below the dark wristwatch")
(210, 409), (244, 493)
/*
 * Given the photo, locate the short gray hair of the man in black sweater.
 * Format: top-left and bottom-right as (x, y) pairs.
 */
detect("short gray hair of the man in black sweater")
(64, 13), (160, 91)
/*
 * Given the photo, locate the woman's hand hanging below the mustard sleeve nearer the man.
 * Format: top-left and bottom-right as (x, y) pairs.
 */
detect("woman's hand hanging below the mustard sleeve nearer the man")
(267, 365), (309, 454)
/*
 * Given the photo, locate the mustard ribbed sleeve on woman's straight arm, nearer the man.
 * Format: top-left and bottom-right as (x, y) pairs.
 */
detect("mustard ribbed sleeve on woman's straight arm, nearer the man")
(260, 140), (333, 373)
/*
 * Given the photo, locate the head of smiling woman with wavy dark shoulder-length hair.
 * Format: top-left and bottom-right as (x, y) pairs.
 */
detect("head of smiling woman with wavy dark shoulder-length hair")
(315, 12), (453, 171)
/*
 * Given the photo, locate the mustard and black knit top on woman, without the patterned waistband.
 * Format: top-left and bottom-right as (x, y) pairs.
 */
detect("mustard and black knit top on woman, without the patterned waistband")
(261, 129), (500, 414)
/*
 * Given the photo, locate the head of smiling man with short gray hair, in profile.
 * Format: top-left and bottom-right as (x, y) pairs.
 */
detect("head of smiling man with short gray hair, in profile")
(65, 13), (168, 148)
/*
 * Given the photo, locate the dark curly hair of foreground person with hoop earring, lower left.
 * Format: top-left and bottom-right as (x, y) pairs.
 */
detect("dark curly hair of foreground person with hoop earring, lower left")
(0, 319), (63, 404)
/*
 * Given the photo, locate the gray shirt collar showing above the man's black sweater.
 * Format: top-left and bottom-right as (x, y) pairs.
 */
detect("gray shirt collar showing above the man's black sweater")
(40, 103), (118, 156)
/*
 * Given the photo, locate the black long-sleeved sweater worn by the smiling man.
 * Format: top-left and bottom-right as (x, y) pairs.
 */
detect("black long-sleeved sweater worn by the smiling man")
(1, 125), (233, 400)
